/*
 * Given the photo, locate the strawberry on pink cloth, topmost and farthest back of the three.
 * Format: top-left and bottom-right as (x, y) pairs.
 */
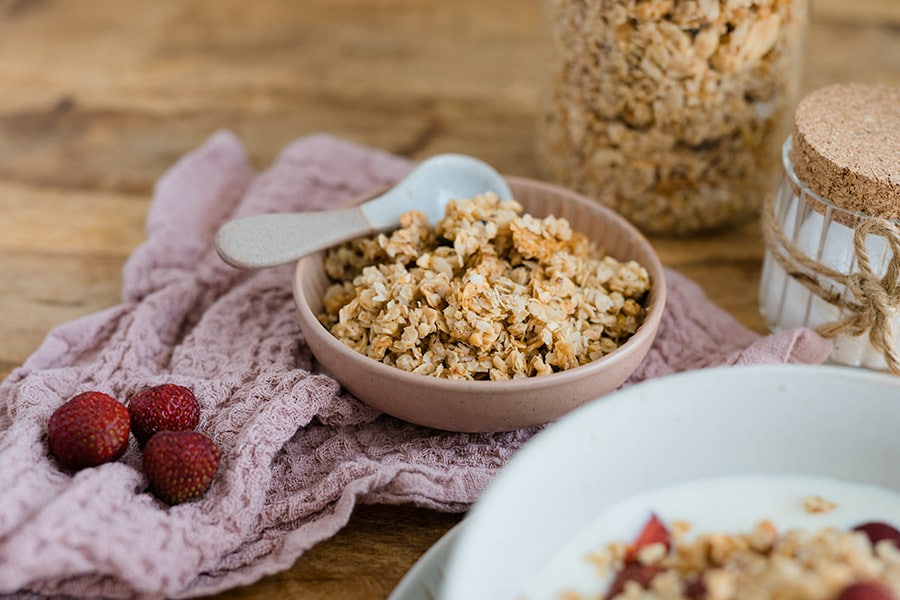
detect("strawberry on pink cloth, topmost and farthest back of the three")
(128, 383), (200, 447)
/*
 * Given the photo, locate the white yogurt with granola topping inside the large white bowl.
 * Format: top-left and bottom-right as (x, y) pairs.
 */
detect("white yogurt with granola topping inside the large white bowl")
(525, 474), (900, 600)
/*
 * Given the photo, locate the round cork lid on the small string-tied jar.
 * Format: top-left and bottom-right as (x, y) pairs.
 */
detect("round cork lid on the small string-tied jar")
(791, 84), (900, 219)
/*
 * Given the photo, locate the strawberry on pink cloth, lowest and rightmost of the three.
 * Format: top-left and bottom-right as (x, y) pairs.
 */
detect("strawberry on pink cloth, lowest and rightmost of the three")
(144, 431), (219, 504)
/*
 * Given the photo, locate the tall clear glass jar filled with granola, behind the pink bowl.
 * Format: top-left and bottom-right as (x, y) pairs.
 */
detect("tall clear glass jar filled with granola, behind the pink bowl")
(538, 0), (808, 234)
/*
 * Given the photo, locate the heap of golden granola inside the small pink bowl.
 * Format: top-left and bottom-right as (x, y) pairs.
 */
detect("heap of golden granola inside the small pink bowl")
(320, 193), (650, 380)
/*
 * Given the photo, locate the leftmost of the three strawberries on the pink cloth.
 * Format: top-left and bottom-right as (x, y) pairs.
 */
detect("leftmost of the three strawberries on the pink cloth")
(47, 392), (130, 469)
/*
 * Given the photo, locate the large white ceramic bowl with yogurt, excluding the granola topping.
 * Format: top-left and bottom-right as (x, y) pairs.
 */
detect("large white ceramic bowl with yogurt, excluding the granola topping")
(441, 366), (900, 600)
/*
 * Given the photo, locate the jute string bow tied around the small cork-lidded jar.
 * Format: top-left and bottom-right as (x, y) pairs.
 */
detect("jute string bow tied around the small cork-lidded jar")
(762, 190), (900, 375)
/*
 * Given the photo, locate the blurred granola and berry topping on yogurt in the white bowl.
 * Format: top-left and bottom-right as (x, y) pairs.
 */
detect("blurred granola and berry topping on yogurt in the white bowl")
(588, 520), (900, 600)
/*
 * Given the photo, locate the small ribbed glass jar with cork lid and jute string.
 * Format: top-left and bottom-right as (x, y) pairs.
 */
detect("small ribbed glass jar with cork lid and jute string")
(760, 84), (900, 374)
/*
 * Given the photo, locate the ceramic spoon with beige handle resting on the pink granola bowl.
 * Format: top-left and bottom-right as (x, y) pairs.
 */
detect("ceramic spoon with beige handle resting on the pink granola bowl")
(216, 154), (512, 269)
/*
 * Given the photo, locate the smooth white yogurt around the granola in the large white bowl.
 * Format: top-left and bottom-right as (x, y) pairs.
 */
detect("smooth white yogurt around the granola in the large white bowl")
(522, 474), (900, 600)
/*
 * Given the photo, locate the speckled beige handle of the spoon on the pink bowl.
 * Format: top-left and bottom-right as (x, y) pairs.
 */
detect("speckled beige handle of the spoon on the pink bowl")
(216, 207), (375, 269)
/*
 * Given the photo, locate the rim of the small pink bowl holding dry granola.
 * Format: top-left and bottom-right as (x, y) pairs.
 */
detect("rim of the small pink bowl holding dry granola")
(293, 175), (667, 393)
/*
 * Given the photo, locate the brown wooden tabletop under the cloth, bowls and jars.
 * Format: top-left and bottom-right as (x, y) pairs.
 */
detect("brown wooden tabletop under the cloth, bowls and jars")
(0, 0), (900, 599)
